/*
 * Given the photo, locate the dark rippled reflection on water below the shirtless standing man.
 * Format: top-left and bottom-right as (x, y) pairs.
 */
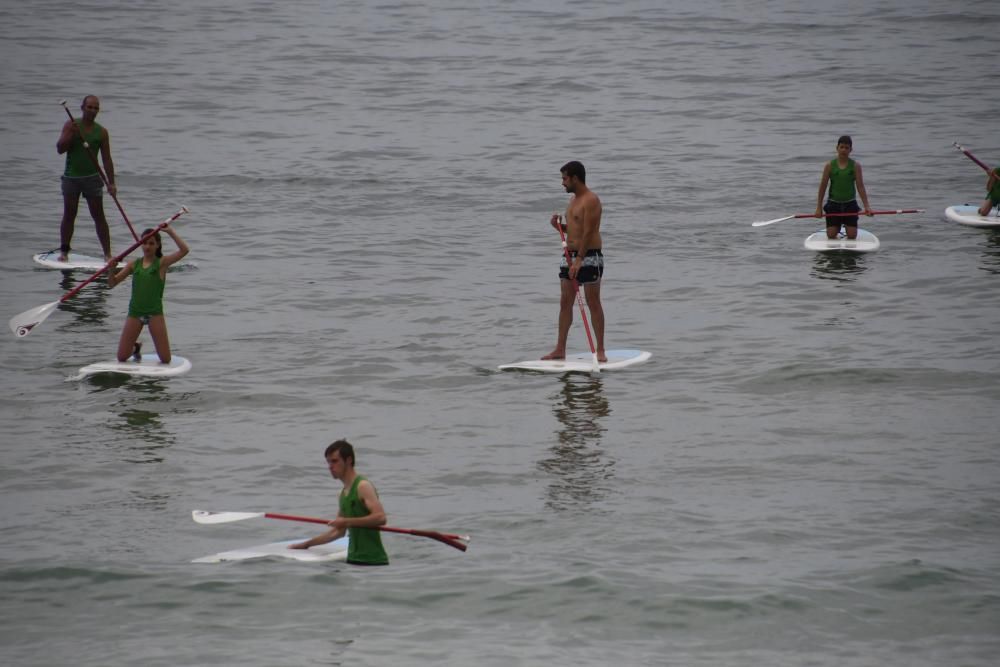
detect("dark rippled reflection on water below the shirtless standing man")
(538, 373), (614, 510)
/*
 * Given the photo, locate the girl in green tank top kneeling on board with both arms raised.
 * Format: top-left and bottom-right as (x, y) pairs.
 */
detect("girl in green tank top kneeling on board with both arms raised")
(108, 225), (188, 364)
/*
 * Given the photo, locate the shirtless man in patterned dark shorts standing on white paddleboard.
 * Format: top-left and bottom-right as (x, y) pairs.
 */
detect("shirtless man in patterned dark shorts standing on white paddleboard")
(542, 160), (608, 362)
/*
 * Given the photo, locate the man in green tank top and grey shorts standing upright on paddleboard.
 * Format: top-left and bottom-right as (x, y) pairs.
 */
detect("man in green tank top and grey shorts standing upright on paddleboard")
(56, 95), (118, 262)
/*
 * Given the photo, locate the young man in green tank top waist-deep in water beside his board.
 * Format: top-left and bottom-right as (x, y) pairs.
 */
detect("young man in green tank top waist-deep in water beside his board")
(288, 440), (389, 565)
